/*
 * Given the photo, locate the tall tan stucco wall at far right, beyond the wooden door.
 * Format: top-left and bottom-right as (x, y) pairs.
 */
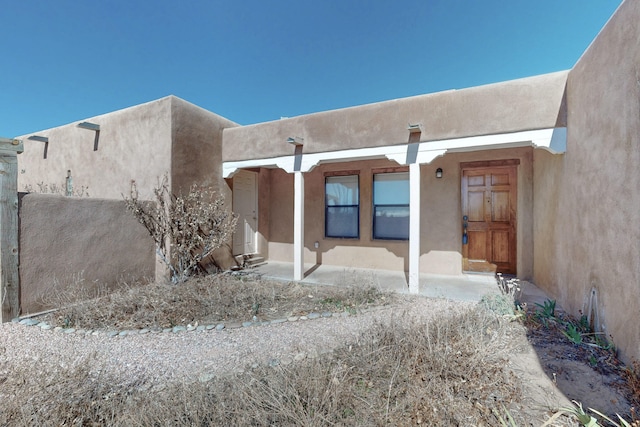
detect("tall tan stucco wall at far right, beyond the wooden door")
(534, 0), (640, 360)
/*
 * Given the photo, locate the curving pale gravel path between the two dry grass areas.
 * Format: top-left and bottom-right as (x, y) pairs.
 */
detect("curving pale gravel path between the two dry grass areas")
(0, 298), (474, 385)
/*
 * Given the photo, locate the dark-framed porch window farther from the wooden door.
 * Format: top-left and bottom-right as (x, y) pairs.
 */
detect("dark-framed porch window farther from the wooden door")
(324, 175), (360, 239)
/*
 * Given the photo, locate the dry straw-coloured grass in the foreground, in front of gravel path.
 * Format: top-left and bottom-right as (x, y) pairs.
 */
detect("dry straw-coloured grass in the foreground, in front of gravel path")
(0, 309), (525, 426)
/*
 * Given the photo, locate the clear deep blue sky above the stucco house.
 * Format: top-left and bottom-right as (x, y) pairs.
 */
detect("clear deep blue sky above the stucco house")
(0, 0), (620, 137)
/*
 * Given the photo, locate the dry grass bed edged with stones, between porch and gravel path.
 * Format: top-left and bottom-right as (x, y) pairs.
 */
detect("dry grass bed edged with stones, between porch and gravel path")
(48, 274), (393, 329)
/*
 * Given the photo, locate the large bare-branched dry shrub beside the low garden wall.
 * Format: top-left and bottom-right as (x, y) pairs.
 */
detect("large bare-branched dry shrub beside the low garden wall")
(124, 175), (237, 283)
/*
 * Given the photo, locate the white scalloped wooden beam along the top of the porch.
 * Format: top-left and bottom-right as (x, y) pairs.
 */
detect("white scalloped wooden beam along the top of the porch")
(222, 128), (567, 178)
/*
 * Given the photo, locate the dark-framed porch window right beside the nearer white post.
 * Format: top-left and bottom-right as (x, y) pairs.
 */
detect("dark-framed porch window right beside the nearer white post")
(373, 172), (409, 240)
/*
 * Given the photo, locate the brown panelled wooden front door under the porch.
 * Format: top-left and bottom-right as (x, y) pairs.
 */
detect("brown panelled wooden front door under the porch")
(462, 160), (519, 274)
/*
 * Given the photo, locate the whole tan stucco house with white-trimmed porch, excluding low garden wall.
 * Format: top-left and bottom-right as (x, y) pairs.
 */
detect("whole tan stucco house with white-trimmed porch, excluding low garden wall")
(13, 0), (640, 358)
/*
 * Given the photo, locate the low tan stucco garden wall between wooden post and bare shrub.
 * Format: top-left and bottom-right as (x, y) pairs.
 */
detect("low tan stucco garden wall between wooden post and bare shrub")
(19, 194), (155, 314)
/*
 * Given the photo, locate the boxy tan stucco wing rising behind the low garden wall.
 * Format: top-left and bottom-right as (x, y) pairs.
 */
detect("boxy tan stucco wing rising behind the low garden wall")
(18, 96), (237, 199)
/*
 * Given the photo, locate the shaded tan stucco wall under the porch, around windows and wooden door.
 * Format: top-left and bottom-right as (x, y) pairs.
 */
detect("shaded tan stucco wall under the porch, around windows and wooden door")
(258, 148), (533, 278)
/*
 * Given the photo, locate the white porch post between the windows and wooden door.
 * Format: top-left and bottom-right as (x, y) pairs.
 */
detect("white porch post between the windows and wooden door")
(409, 162), (420, 294)
